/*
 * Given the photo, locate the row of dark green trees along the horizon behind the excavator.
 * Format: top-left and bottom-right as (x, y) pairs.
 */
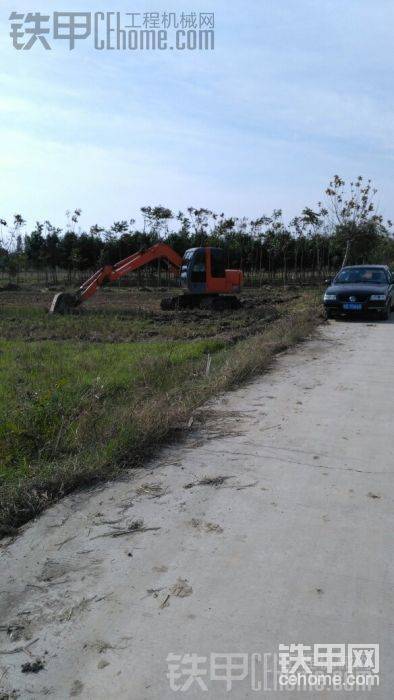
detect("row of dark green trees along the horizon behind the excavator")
(0, 175), (394, 281)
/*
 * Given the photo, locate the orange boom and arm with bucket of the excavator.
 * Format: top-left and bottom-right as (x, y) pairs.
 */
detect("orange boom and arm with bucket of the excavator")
(49, 243), (182, 314)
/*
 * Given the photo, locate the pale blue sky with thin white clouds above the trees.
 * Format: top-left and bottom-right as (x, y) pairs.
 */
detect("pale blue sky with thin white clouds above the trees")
(0, 0), (394, 226)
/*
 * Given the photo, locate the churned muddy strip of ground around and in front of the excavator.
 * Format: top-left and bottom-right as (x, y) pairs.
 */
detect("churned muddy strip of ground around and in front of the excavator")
(0, 286), (311, 342)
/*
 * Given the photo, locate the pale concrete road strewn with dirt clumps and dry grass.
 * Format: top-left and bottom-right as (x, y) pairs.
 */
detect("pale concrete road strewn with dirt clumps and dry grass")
(0, 322), (394, 700)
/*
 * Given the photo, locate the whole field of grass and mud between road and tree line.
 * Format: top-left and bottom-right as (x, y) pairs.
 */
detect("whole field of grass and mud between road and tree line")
(0, 288), (320, 532)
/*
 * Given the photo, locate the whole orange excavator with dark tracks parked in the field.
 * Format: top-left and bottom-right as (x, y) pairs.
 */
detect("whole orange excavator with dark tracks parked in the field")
(50, 243), (243, 314)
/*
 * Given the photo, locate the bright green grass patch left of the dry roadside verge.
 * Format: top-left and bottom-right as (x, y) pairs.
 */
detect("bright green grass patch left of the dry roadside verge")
(0, 340), (223, 480)
